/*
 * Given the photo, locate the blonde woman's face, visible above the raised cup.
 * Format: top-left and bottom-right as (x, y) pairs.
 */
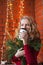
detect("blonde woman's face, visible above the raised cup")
(20, 19), (31, 33)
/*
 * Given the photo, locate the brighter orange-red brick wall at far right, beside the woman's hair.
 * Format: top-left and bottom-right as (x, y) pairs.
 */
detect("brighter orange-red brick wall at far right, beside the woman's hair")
(35, 0), (43, 62)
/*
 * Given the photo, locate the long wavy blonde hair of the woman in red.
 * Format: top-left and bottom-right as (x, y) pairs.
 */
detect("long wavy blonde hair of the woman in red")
(16, 16), (40, 40)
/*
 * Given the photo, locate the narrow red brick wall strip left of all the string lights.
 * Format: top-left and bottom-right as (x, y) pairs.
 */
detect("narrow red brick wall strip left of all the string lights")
(0, 0), (6, 59)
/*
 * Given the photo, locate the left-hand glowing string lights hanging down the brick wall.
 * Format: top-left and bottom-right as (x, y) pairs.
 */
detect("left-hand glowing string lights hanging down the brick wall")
(1, 0), (14, 60)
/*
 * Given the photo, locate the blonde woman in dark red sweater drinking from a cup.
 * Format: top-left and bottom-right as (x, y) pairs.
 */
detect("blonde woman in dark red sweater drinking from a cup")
(12, 16), (40, 65)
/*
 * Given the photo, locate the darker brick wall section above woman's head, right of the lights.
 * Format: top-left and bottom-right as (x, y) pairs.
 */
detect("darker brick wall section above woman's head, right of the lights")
(24, 0), (35, 18)
